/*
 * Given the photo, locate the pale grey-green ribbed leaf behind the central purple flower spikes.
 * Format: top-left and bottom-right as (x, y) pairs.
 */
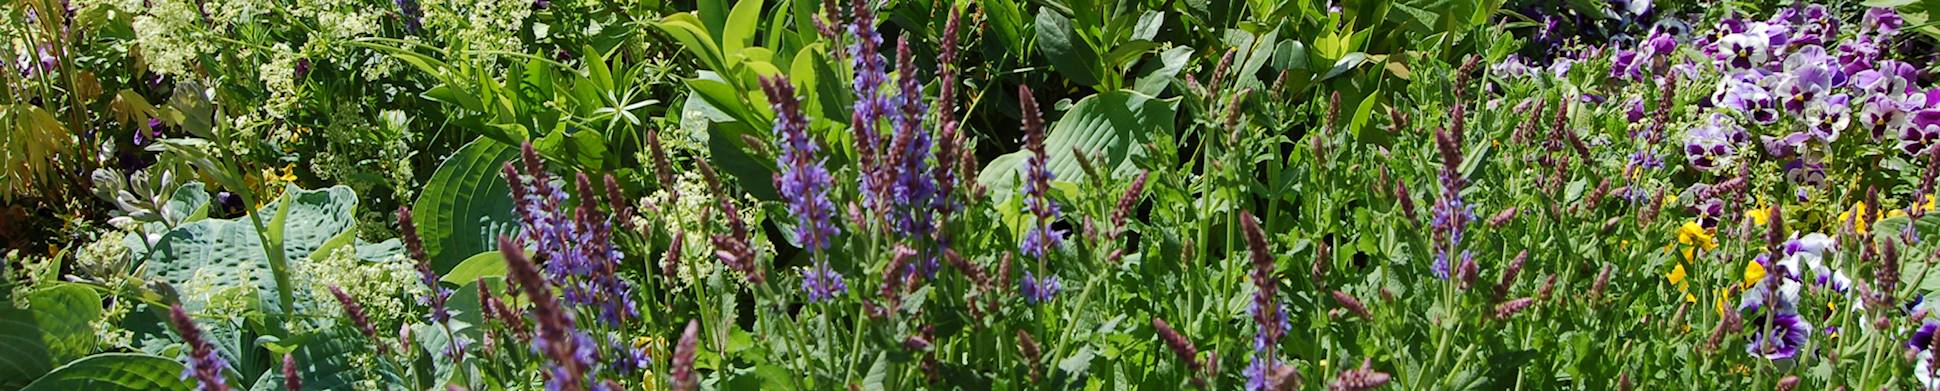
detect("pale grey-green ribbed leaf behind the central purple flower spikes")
(978, 91), (1178, 199)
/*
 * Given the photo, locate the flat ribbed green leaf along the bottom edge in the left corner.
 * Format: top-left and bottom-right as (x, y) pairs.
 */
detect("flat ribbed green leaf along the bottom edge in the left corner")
(21, 352), (196, 391)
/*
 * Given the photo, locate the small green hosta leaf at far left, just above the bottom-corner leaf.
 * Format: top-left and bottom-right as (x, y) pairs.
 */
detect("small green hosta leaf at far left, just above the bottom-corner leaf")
(27, 283), (101, 362)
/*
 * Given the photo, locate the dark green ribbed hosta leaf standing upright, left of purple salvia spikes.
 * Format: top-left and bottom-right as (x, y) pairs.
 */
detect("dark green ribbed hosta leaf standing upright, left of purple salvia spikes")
(411, 139), (520, 273)
